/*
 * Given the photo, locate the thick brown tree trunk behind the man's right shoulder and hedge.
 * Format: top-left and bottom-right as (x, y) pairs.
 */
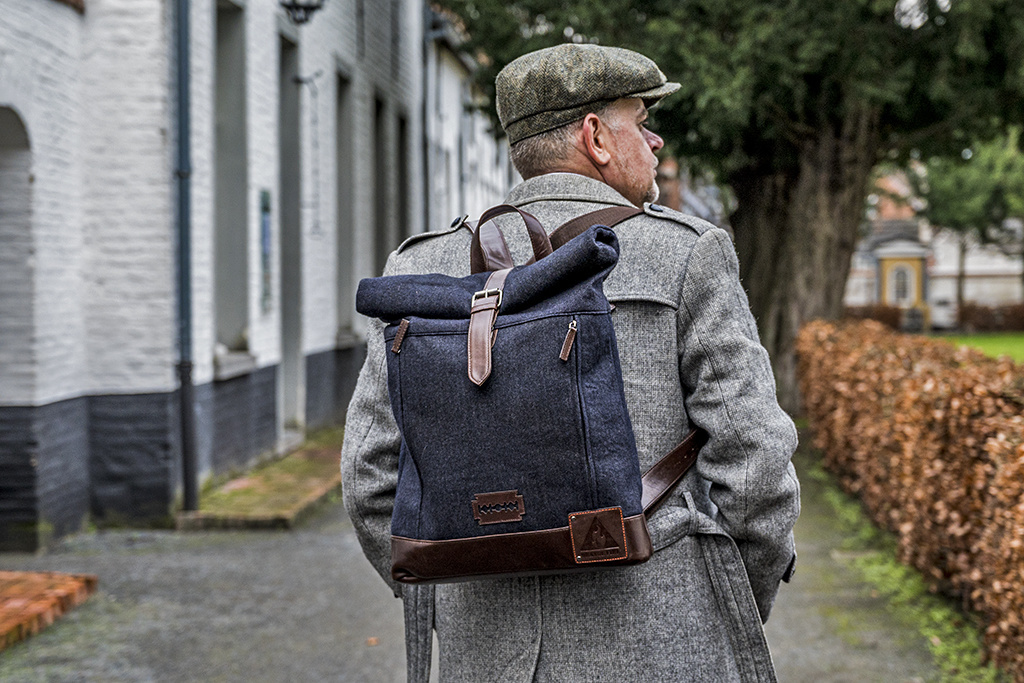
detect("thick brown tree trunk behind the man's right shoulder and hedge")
(729, 110), (879, 414)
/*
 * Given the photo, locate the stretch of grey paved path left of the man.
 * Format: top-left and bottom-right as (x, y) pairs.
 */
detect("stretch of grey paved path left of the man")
(0, 504), (404, 683)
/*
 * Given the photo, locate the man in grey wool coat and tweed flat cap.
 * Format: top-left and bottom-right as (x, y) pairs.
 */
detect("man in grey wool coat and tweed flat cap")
(342, 45), (800, 683)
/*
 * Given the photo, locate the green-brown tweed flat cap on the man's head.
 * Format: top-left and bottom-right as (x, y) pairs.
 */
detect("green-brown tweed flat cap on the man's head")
(495, 43), (679, 144)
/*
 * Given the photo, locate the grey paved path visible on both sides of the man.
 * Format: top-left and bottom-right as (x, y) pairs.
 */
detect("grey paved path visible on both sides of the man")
(0, 446), (934, 683)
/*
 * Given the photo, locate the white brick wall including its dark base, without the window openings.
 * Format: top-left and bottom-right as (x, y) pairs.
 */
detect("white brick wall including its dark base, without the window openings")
(0, 0), (507, 532)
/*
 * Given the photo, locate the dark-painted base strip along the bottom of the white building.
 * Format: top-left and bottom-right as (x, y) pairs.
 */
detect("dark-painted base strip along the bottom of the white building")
(0, 345), (366, 552)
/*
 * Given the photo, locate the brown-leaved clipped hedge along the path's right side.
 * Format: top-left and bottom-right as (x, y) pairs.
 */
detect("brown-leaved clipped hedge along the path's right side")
(797, 321), (1024, 683)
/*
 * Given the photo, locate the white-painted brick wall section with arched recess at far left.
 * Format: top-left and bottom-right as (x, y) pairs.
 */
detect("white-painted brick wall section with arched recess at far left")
(0, 0), (86, 405)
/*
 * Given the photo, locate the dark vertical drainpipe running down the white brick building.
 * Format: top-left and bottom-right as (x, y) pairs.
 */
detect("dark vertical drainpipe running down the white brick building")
(174, 0), (199, 511)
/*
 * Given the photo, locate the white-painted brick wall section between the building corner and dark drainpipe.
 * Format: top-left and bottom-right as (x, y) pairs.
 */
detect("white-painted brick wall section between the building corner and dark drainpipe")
(81, 0), (176, 393)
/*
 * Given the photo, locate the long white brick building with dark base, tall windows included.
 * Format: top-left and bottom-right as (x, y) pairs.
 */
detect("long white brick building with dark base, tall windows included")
(0, 0), (512, 549)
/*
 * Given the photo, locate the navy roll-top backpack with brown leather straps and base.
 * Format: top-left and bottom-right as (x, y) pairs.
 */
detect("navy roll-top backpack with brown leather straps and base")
(356, 205), (702, 583)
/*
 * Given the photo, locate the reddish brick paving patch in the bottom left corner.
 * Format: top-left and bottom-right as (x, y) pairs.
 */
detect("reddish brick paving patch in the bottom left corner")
(0, 571), (97, 651)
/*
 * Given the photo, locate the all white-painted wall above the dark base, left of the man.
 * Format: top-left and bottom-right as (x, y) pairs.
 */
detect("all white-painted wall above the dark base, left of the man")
(0, 0), (514, 413)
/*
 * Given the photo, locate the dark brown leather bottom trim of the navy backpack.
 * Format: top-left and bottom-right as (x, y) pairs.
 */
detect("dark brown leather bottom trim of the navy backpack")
(391, 513), (652, 584)
